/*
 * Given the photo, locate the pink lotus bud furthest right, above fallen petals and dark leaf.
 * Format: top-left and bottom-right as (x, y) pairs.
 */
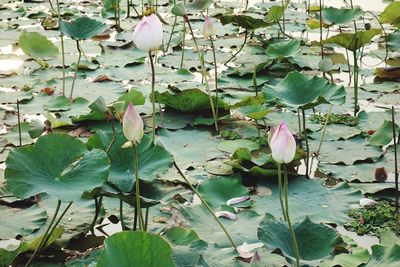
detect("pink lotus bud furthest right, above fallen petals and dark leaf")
(270, 122), (296, 163)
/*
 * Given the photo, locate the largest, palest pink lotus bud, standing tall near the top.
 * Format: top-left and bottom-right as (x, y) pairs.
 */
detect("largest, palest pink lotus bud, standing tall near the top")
(133, 13), (163, 52)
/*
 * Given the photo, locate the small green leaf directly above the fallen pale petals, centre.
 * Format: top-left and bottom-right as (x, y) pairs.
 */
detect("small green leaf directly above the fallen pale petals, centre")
(198, 178), (249, 209)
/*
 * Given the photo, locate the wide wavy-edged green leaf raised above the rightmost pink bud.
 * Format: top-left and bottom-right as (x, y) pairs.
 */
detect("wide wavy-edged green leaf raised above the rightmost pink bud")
(264, 72), (346, 109)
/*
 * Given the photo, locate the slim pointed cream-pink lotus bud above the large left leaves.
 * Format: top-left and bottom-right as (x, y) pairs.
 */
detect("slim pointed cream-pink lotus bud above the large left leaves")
(122, 103), (143, 144)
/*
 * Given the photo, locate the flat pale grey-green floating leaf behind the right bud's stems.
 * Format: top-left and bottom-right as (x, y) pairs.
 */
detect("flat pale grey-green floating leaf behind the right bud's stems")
(252, 178), (362, 224)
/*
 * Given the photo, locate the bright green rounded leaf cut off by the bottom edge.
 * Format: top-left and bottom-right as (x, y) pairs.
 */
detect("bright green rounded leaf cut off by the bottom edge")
(96, 231), (175, 267)
